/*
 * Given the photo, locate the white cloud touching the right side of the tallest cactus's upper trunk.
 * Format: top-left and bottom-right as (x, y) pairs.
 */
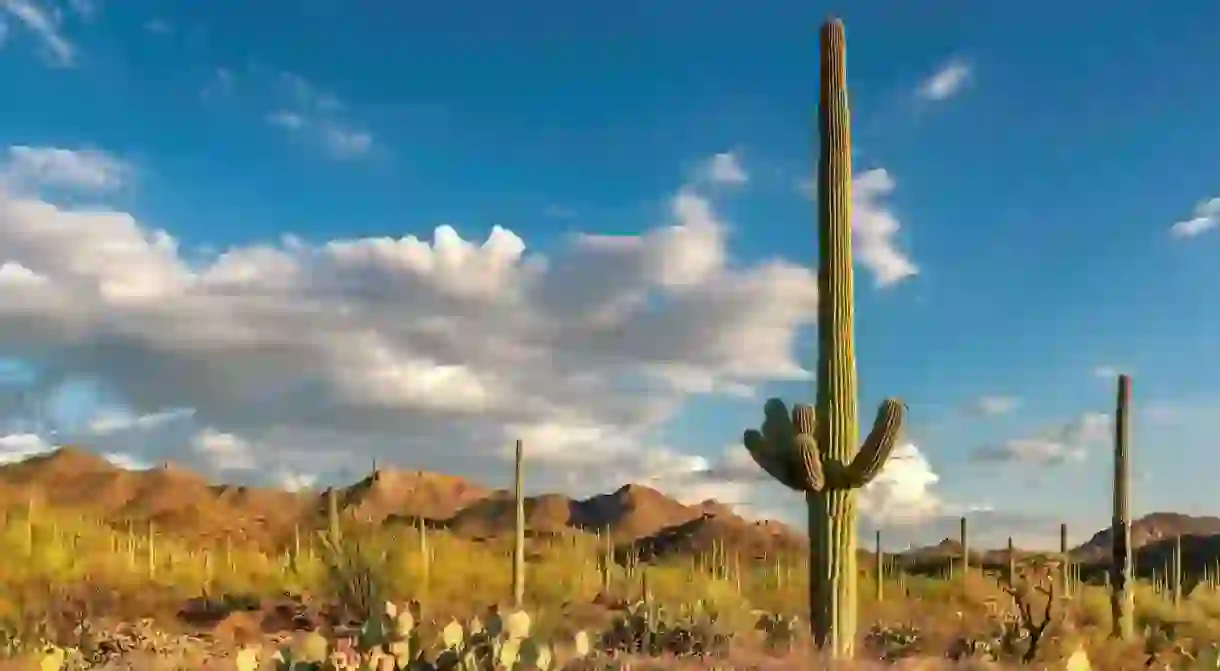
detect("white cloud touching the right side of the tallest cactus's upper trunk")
(802, 168), (919, 288)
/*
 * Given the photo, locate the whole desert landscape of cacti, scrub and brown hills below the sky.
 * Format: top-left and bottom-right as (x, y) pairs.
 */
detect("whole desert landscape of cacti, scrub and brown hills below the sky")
(0, 13), (1220, 671)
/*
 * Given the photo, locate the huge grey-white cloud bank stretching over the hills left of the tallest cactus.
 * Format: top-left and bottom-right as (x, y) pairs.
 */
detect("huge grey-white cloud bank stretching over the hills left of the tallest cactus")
(0, 147), (816, 505)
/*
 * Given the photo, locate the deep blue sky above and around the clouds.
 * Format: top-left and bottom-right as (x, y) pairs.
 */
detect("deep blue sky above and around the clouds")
(0, 0), (1220, 549)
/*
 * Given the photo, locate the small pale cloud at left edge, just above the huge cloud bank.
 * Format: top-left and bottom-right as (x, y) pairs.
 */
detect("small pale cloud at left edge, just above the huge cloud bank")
(0, 145), (132, 193)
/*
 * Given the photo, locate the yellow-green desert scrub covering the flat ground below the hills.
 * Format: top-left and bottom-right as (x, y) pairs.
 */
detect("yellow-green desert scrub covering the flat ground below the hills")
(0, 509), (1220, 670)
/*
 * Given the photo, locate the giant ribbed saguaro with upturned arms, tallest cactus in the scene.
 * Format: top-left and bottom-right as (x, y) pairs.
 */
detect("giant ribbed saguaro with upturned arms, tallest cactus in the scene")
(744, 20), (905, 660)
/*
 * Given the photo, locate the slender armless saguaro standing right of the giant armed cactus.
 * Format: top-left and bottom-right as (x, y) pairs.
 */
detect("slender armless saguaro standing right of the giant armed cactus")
(1110, 375), (1136, 641)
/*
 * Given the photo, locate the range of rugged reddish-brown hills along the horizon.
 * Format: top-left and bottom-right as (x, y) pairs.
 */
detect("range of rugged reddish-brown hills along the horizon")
(0, 448), (1220, 571)
